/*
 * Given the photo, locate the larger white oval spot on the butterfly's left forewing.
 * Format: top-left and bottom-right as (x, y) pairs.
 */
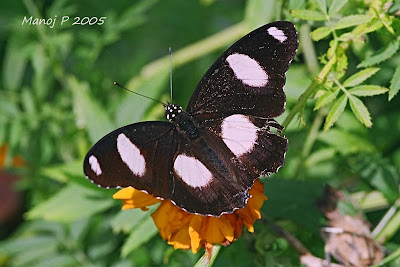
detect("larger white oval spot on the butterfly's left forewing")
(117, 133), (146, 176)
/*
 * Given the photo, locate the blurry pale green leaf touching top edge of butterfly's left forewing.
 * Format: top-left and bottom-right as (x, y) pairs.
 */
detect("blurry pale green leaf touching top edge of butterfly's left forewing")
(67, 77), (116, 143)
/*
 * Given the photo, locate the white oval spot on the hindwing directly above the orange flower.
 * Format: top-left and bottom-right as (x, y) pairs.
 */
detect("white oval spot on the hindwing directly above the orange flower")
(174, 154), (213, 187)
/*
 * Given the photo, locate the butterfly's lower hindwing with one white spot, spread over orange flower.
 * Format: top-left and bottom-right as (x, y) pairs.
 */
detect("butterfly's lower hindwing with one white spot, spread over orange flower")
(171, 128), (254, 216)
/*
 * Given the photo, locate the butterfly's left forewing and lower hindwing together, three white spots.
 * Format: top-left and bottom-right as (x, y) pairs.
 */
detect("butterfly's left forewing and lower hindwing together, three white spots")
(84, 121), (249, 216)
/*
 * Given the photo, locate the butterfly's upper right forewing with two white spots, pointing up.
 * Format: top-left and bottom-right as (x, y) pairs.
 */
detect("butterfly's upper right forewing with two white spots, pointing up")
(187, 21), (298, 121)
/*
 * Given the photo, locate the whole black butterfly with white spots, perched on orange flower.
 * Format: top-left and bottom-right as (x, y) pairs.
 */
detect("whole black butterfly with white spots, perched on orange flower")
(83, 21), (298, 217)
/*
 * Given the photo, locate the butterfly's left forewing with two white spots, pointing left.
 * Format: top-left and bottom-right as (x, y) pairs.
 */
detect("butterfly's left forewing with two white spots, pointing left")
(83, 121), (177, 198)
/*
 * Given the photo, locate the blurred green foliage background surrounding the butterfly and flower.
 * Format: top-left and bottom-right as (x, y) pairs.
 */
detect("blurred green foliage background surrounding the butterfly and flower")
(0, 0), (400, 266)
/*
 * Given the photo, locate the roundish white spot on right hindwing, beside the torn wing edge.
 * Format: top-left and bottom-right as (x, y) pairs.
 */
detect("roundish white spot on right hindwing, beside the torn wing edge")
(221, 114), (258, 157)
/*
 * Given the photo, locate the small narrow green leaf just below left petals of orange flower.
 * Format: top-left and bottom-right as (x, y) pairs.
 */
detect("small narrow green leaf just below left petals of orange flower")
(121, 216), (158, 257)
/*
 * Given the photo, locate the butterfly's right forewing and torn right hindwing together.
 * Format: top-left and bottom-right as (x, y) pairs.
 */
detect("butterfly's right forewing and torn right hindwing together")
(187, 21), (298, 182)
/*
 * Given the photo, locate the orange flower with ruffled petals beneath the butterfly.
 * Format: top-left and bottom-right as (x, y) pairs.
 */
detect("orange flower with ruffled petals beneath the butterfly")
(114, 179), (267, 253)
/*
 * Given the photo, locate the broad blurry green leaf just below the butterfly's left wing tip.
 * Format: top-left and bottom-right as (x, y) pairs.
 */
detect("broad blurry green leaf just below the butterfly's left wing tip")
(26, 184), (115, 222)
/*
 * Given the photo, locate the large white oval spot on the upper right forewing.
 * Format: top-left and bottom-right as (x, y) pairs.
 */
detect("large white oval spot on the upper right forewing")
(226, 54), (268, 87)
